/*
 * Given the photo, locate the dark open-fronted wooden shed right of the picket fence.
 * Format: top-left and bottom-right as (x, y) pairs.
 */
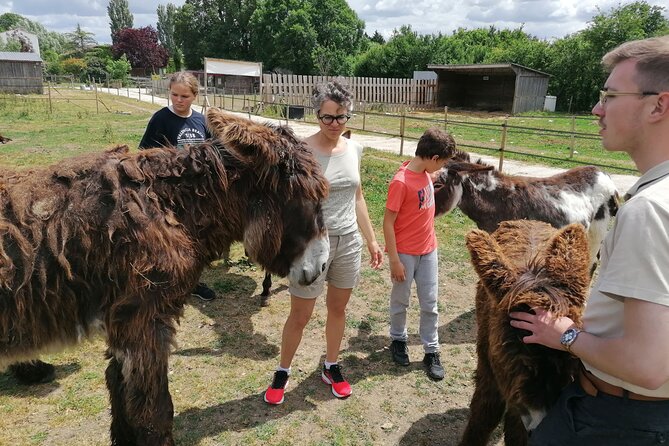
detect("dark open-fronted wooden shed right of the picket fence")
(428, 63), (550, 114)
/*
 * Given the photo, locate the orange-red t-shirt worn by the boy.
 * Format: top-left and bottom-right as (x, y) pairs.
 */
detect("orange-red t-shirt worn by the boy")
(386, 161), (437, 256)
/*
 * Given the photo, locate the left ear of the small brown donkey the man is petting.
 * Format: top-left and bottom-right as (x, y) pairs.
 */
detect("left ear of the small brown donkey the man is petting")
(465, 229), (518, 296)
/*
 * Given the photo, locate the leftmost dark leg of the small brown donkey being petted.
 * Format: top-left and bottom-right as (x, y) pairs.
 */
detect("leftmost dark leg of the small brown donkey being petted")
(460, 358), (505, 446)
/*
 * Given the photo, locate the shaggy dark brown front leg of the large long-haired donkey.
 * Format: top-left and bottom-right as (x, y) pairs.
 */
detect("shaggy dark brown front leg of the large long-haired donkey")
(107, 315), (174, 446)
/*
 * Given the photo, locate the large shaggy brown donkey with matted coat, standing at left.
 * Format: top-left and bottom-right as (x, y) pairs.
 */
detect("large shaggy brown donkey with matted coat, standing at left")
(0, 110), (328, 446)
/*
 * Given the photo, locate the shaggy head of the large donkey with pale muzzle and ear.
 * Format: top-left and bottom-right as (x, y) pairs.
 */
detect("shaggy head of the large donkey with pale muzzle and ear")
(207, 108), (329, 284)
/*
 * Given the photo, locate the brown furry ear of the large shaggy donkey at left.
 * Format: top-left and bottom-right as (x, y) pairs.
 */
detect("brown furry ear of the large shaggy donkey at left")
(207, 107), (282, 165)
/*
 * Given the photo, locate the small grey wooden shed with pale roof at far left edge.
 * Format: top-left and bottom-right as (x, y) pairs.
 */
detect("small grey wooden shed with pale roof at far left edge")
(0, 51), (44, 94)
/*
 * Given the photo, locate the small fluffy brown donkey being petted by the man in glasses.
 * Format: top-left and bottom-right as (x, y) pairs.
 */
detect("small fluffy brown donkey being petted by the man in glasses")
(460, 220), (590, 446)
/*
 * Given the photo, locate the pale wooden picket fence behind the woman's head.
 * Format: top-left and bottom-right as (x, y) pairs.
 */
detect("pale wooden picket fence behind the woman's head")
(262, 74), (437, 110)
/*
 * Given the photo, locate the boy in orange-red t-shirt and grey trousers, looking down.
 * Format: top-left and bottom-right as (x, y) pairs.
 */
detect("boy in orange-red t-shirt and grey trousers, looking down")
(383, 128), (455, 380)
